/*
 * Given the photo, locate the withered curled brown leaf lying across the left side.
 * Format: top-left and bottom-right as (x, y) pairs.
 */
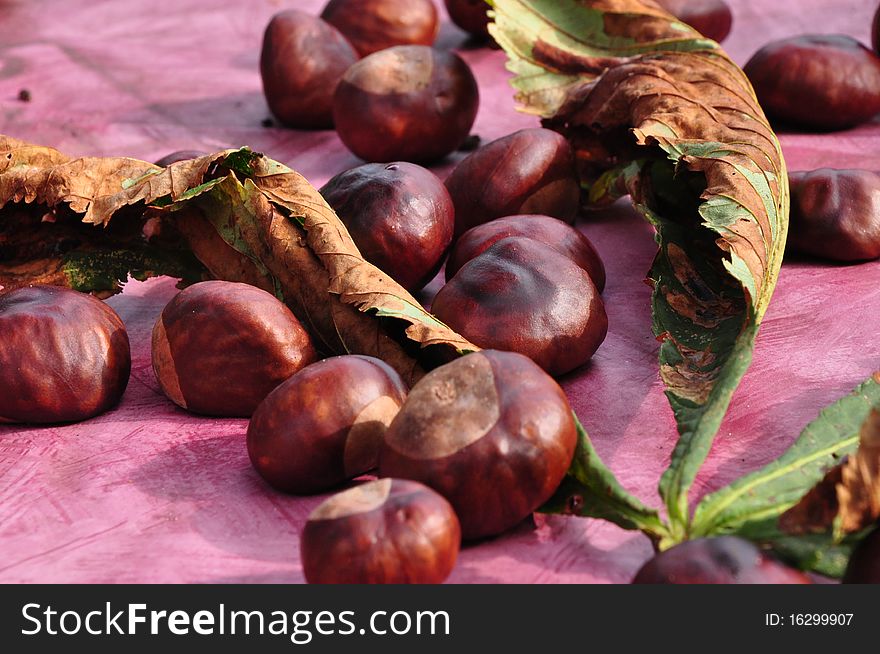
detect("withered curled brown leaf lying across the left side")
(0, 136), (478, 383)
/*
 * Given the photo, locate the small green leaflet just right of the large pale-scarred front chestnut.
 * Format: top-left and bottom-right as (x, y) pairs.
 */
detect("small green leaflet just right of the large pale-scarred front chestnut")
(540, 416), (668, 543)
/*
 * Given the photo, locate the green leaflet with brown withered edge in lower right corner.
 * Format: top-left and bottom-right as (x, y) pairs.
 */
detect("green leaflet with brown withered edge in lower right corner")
(691, 373), (880, 577)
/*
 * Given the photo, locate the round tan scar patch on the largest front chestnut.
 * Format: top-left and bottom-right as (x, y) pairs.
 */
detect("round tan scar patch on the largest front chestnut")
(385, 353), (500, 460)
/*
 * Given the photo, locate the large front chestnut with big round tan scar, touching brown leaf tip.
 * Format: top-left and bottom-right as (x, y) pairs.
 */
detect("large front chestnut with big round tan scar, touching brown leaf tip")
(379, 350), (577, 539)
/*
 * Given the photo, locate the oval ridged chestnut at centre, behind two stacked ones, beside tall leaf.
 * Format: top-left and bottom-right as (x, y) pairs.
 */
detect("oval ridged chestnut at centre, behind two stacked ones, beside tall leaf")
(446, 128), (580, 238)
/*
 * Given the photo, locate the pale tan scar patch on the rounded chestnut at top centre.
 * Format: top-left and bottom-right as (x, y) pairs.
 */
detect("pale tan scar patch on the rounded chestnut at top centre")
(345, 48), (434, 95)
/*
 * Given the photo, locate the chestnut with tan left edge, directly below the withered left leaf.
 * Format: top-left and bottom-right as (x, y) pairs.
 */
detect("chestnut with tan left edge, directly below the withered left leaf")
(152, 281), (316, 417)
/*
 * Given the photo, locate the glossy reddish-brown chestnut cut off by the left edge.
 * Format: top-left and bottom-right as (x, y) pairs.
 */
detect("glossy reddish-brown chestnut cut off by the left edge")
(0, 286), (131, 423)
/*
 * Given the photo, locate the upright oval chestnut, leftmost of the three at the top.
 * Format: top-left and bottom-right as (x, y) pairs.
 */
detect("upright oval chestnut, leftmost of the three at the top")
(260, 9), (358, 129)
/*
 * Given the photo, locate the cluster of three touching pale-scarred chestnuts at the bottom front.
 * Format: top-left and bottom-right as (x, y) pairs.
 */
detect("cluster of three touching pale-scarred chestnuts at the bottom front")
(247, 350), (577, 583)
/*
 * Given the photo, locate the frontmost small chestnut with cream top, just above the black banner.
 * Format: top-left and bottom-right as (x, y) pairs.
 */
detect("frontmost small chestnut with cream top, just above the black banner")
(300, 479), (461, 584)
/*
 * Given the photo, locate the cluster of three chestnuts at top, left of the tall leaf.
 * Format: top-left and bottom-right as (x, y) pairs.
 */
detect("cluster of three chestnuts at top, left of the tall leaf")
(260, 0), (478, 163)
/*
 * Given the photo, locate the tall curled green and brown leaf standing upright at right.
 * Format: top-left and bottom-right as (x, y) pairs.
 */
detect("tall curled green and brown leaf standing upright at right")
(490, 0), (789, 540)
